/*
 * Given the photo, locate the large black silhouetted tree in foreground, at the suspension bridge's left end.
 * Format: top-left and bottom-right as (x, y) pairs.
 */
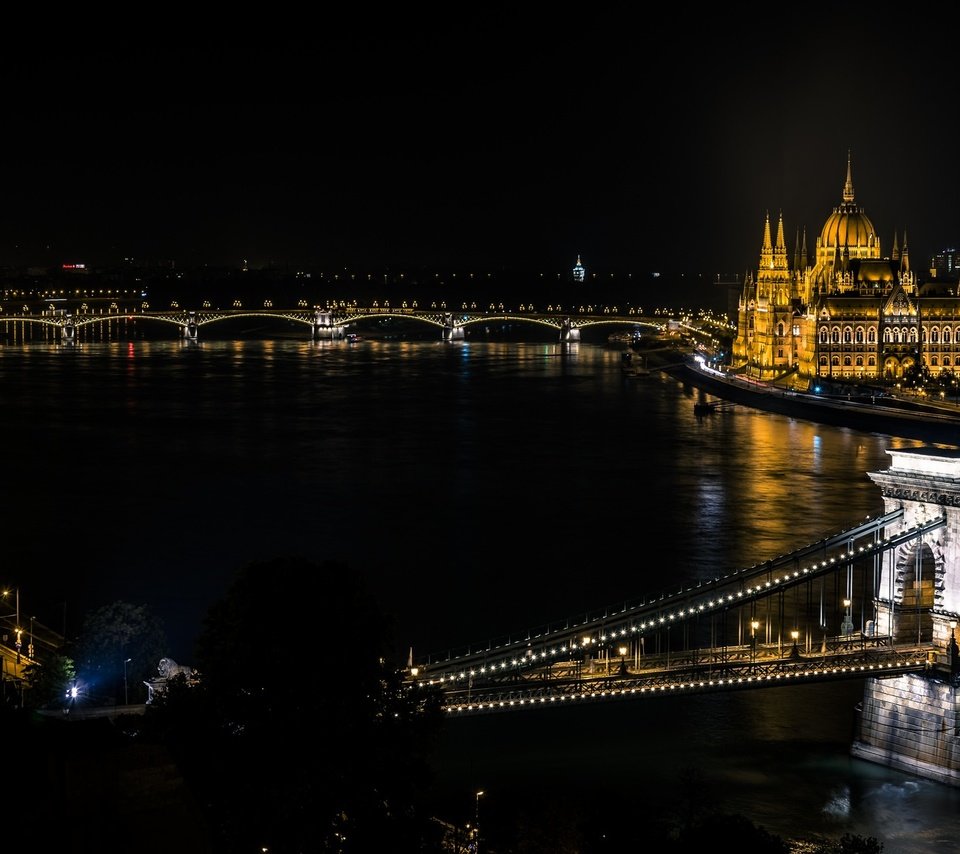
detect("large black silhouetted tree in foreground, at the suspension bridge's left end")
(147, 558), (439, 852)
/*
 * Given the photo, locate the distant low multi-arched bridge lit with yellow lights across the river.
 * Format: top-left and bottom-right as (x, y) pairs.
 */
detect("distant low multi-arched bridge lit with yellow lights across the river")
(0, 306), (668, 342)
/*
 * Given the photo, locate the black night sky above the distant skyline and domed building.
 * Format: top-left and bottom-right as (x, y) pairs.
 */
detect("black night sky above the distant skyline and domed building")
(0, 13), (960, 292)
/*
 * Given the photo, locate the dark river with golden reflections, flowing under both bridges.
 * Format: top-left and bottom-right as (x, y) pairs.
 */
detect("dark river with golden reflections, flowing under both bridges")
(0, 339), (960, 854)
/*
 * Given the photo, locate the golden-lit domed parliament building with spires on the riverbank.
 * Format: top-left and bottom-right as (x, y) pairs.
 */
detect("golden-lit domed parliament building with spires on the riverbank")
(732, 156), (960, 387)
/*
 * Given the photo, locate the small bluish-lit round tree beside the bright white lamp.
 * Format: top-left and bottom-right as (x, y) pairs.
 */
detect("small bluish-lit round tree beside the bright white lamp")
(72, 601), (169, 703)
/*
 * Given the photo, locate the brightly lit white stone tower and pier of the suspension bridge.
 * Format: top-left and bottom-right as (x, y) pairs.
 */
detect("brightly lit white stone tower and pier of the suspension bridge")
(851, 448), (960, 787)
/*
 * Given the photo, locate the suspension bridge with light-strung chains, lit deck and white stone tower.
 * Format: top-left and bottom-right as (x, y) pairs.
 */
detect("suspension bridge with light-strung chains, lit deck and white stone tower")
(406, 449), (960, 715)
